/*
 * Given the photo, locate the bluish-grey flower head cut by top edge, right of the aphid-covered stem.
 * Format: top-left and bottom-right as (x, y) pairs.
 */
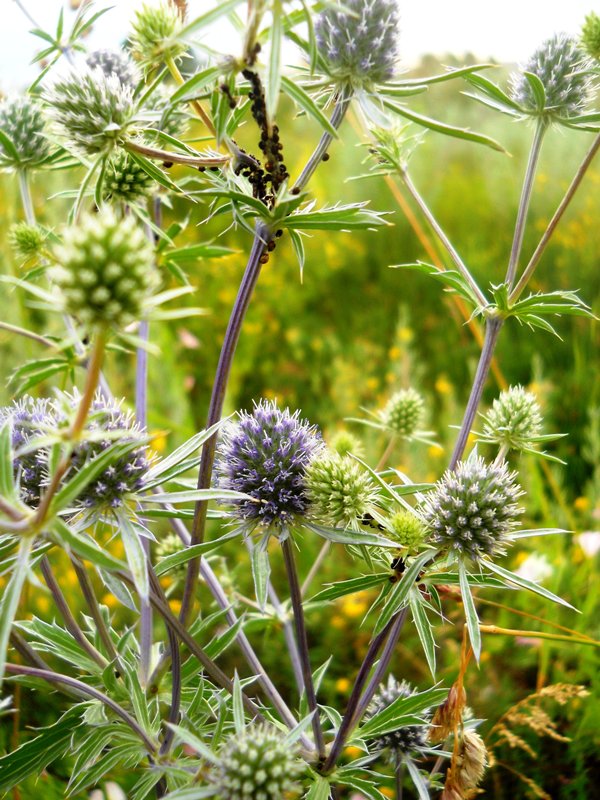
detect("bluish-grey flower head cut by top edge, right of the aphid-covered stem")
(315, 0), (398, 87)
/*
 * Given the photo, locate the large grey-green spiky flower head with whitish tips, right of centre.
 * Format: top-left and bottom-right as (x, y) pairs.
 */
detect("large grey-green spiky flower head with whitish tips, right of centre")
(419, 456), (523, 561)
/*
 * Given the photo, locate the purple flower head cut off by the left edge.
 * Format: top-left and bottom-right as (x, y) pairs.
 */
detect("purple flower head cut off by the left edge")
(0, 395), (56, 507)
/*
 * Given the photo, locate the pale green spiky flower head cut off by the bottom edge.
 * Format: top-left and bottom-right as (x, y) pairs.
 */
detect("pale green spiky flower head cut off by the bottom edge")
(211, 725), (302, 800)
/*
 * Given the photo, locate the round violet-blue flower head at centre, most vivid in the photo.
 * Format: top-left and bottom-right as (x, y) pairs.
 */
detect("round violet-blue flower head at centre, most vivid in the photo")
(215, 400), (322, 528)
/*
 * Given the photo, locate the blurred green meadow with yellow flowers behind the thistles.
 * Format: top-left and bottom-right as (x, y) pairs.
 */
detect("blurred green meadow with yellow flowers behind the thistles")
(0, 59), (600, 800)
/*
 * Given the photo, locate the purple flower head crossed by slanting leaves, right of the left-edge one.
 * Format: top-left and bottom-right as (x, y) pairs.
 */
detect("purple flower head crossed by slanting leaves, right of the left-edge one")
(62, 394), (151, 511)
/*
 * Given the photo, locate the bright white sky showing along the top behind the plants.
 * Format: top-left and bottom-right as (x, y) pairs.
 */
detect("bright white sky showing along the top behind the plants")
(0, 0), (600, 91)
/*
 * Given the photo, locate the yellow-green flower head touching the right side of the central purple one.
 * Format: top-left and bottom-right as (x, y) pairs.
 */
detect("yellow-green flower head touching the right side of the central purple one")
(305, 450), (379, 530)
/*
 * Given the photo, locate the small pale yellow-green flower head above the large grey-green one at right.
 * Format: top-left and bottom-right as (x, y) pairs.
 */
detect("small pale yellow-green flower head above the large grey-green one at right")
(482, 386), (542, 450)
